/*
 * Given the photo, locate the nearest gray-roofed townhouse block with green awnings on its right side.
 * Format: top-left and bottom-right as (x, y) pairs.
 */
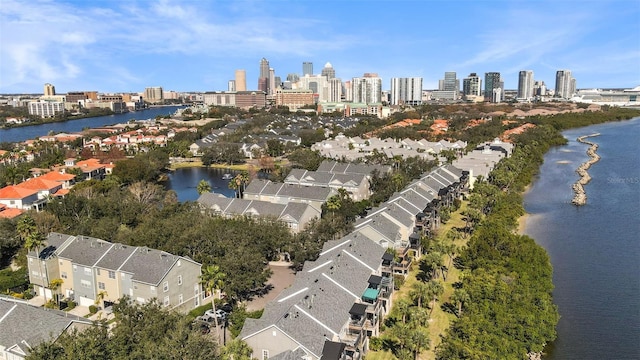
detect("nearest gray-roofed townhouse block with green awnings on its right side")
(240, 234), (393, 360)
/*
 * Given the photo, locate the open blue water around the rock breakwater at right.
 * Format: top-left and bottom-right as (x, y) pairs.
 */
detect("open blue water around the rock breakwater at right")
(525, 118), (640, 360)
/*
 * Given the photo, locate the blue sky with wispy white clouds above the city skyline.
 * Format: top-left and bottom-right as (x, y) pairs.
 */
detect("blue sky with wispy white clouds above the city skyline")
(0, 0), (640, 93)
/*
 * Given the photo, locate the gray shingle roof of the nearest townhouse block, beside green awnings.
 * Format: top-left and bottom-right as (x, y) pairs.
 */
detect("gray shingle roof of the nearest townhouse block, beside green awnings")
(240, 233), (385, 356)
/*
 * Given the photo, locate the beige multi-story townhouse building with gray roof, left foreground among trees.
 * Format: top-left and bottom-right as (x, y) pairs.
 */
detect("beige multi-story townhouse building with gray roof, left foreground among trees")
(27, 233), (204, 312)
